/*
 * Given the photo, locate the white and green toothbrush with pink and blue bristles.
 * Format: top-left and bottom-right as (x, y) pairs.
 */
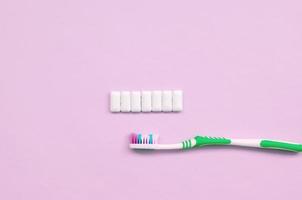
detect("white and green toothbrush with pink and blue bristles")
(129, 133), (302, 152)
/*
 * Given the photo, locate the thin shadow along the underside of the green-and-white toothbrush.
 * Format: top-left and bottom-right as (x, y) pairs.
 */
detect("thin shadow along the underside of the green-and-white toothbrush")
(130, 146), (299, 156)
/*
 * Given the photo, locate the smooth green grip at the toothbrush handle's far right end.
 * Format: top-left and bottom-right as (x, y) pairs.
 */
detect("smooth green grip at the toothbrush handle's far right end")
(260, 140), (302, 152)
